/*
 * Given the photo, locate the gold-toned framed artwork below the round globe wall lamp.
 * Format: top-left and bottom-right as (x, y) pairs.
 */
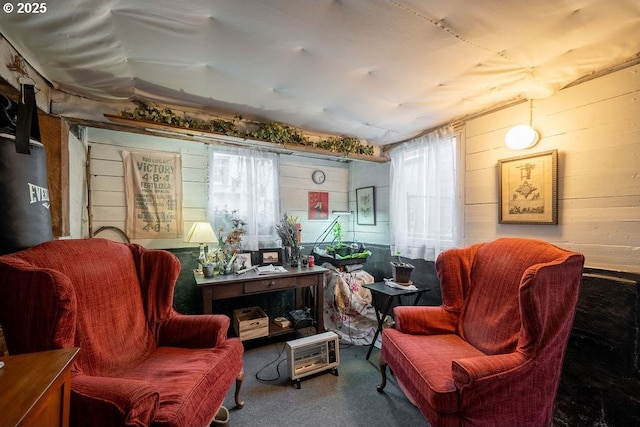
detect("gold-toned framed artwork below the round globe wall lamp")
(498, 150), (558, 224)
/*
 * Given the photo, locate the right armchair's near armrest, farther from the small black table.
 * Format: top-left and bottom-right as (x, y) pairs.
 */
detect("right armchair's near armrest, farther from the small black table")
(451, 351), (530, 389)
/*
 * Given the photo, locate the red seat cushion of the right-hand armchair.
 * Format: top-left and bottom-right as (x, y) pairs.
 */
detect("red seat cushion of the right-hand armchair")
(381, 329), (484, 413)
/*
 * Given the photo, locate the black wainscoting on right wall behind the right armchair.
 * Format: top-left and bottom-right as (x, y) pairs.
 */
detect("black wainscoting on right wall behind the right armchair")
(554, 268), (640, 427)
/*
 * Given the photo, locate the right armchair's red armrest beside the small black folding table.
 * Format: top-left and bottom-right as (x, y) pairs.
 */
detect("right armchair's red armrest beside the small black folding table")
(393, 305), (458, 335)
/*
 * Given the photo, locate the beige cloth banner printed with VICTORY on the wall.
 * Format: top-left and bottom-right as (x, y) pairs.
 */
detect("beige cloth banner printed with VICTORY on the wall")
(122, 151), (184, 239)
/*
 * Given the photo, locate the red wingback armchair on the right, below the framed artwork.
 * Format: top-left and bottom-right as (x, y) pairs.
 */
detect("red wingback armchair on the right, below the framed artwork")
(378, 238), (584, 427)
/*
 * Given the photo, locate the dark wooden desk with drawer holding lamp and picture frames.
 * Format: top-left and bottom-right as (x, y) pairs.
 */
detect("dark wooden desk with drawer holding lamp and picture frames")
(193, 266), (327, 333)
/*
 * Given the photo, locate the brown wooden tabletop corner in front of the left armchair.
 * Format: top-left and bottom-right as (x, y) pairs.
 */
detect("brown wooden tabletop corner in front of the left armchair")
(0, 347), (80, 427)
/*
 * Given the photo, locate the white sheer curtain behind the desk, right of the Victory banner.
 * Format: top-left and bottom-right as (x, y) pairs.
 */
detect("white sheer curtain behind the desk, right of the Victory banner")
(208, 146), (280, 250)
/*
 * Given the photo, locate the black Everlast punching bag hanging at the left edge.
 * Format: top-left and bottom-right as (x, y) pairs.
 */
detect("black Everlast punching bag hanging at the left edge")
(0, 84), (53, 255)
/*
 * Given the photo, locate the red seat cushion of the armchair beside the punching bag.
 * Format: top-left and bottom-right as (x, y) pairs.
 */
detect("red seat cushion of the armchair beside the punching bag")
(123, 339), (243, 426)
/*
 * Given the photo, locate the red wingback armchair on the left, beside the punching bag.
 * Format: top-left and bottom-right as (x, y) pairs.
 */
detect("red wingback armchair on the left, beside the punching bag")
(0, 239), (243, 426)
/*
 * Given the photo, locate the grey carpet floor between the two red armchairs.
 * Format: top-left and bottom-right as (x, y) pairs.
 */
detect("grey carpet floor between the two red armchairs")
(224, 341), (428, 427)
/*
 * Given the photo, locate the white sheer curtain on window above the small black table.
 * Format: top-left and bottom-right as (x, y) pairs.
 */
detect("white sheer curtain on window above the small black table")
(389, 127), (460, 261)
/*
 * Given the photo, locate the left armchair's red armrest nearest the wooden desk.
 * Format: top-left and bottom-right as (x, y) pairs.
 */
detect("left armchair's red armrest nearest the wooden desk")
(156, 313), (230, 348)
